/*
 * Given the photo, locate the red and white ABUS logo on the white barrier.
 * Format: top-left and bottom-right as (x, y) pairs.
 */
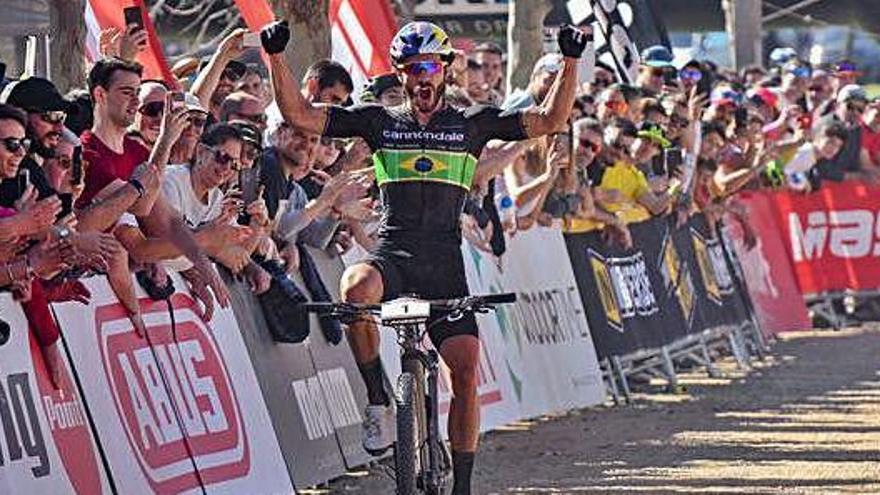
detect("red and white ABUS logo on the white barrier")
(95, 293), (250, 493)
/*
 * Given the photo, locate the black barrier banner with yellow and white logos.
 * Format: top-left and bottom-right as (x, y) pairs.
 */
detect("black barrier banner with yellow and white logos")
(565, 215), (750, 359)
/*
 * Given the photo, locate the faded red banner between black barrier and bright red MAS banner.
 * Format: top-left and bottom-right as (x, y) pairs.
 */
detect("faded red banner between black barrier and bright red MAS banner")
(725, 192), (812, 335)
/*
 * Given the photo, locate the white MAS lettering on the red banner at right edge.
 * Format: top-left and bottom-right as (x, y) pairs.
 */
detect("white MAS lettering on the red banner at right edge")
(788, 210), (880, 262)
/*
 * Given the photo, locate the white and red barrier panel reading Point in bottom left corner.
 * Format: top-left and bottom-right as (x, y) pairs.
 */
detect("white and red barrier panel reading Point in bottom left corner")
(0, 293), (111, 495)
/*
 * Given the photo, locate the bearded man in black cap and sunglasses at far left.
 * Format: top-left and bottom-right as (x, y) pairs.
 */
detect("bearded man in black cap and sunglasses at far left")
(0, 77), (70, 207)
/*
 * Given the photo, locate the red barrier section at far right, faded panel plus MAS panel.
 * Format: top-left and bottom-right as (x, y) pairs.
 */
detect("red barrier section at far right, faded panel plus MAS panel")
(737, 181), (880, 331)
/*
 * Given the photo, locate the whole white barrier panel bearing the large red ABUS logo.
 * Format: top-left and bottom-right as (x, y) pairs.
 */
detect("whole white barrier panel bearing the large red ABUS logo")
(50, 275), (294, 494)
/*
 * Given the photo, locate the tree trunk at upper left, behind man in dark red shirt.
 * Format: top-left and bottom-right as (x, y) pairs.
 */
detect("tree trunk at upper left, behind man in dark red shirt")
(49, 0), (86, 93)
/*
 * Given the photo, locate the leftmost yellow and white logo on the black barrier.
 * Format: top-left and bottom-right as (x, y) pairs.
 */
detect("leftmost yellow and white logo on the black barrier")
(590, 250), (660, 332)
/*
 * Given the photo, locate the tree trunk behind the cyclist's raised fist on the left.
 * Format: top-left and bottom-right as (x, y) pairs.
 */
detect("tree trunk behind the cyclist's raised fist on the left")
(270, 0), (331, 78)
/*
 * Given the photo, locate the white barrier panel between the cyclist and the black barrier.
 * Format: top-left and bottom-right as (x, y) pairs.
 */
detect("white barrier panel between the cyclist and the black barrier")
(463, 227), (605, 417)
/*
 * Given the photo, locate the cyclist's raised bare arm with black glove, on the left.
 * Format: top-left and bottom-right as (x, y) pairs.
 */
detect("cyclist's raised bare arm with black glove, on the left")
(260, 21), (327, 134)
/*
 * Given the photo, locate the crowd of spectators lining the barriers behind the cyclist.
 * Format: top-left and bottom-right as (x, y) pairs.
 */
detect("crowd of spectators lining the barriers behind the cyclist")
(0, 20), (880, 383)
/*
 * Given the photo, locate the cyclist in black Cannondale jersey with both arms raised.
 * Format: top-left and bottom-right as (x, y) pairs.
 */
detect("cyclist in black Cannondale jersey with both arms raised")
(261, 22), (587, 495)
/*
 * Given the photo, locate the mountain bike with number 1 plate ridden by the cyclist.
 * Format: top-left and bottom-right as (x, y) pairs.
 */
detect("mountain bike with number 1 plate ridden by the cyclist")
(303, 294), (516, 495)
